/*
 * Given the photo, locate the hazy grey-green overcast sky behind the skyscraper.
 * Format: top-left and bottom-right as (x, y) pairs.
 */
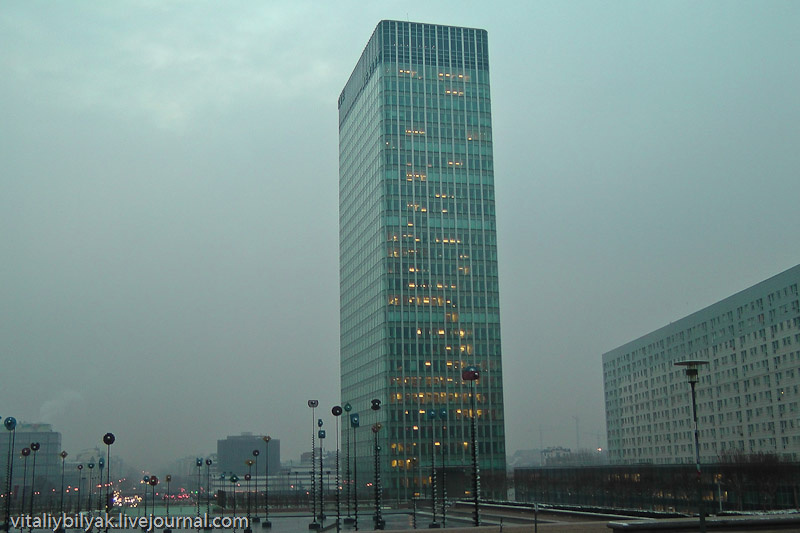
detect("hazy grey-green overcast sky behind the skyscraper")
(0, 1), (800, 467)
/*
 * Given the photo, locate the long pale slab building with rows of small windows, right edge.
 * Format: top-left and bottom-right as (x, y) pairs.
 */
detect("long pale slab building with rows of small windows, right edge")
(603, 265), (800, 464)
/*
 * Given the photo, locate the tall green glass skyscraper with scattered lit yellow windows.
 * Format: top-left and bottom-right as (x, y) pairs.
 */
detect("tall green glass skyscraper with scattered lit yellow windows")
(339, 21), (506, 498)
